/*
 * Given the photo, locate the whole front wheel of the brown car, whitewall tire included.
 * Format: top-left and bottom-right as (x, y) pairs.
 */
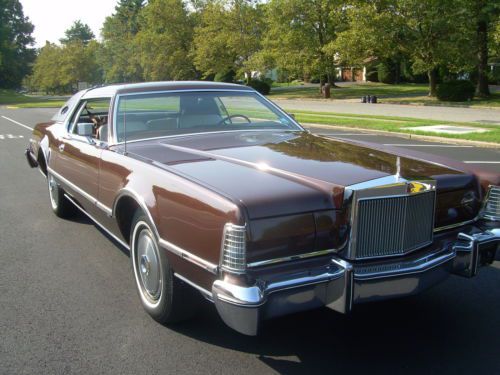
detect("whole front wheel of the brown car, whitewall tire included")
(130, 210), (196, 324)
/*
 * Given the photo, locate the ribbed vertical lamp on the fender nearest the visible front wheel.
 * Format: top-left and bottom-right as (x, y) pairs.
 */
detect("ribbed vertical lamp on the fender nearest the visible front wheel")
(221, 223), (247, 273)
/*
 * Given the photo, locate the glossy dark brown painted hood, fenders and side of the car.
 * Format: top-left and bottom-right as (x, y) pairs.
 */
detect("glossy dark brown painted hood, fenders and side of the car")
(30, 83), (500, 296)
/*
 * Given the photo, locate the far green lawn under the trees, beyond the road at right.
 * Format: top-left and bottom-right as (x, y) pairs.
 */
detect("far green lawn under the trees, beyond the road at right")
(269, 82), (500, 107)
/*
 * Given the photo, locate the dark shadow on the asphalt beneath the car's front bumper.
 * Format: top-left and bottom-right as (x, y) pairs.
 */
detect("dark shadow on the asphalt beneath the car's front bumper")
(171, 264), (500, 374)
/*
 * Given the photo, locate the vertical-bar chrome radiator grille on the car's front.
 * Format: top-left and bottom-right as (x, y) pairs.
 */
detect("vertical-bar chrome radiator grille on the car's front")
(355, 191), (436, 259)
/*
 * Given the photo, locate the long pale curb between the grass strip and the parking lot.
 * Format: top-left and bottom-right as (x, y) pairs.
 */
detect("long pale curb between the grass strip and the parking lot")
(301, 122), (500, 148)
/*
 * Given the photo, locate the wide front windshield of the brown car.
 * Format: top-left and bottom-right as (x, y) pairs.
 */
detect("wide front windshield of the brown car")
(116, 91), (301, 142)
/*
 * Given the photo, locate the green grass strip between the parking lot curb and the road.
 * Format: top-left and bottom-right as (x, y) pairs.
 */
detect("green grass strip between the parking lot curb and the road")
(292, 111), (500, 144)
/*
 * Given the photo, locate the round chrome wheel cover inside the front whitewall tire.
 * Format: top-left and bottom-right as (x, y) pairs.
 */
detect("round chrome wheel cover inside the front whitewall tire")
(133, 225), (163, 304)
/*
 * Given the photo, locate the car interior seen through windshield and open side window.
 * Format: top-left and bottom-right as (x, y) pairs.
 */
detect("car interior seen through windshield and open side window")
(70, 93), (294, 142)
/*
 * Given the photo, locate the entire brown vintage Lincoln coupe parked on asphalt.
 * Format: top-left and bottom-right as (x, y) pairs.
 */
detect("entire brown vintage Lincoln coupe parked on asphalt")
(26, 82), (500, 335)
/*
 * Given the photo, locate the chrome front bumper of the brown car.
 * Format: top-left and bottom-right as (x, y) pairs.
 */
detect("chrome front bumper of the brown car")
(212, 225), (500, 335)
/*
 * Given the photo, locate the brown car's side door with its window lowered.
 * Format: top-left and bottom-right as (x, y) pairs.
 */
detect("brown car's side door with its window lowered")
(54, 98), (110, 213)
